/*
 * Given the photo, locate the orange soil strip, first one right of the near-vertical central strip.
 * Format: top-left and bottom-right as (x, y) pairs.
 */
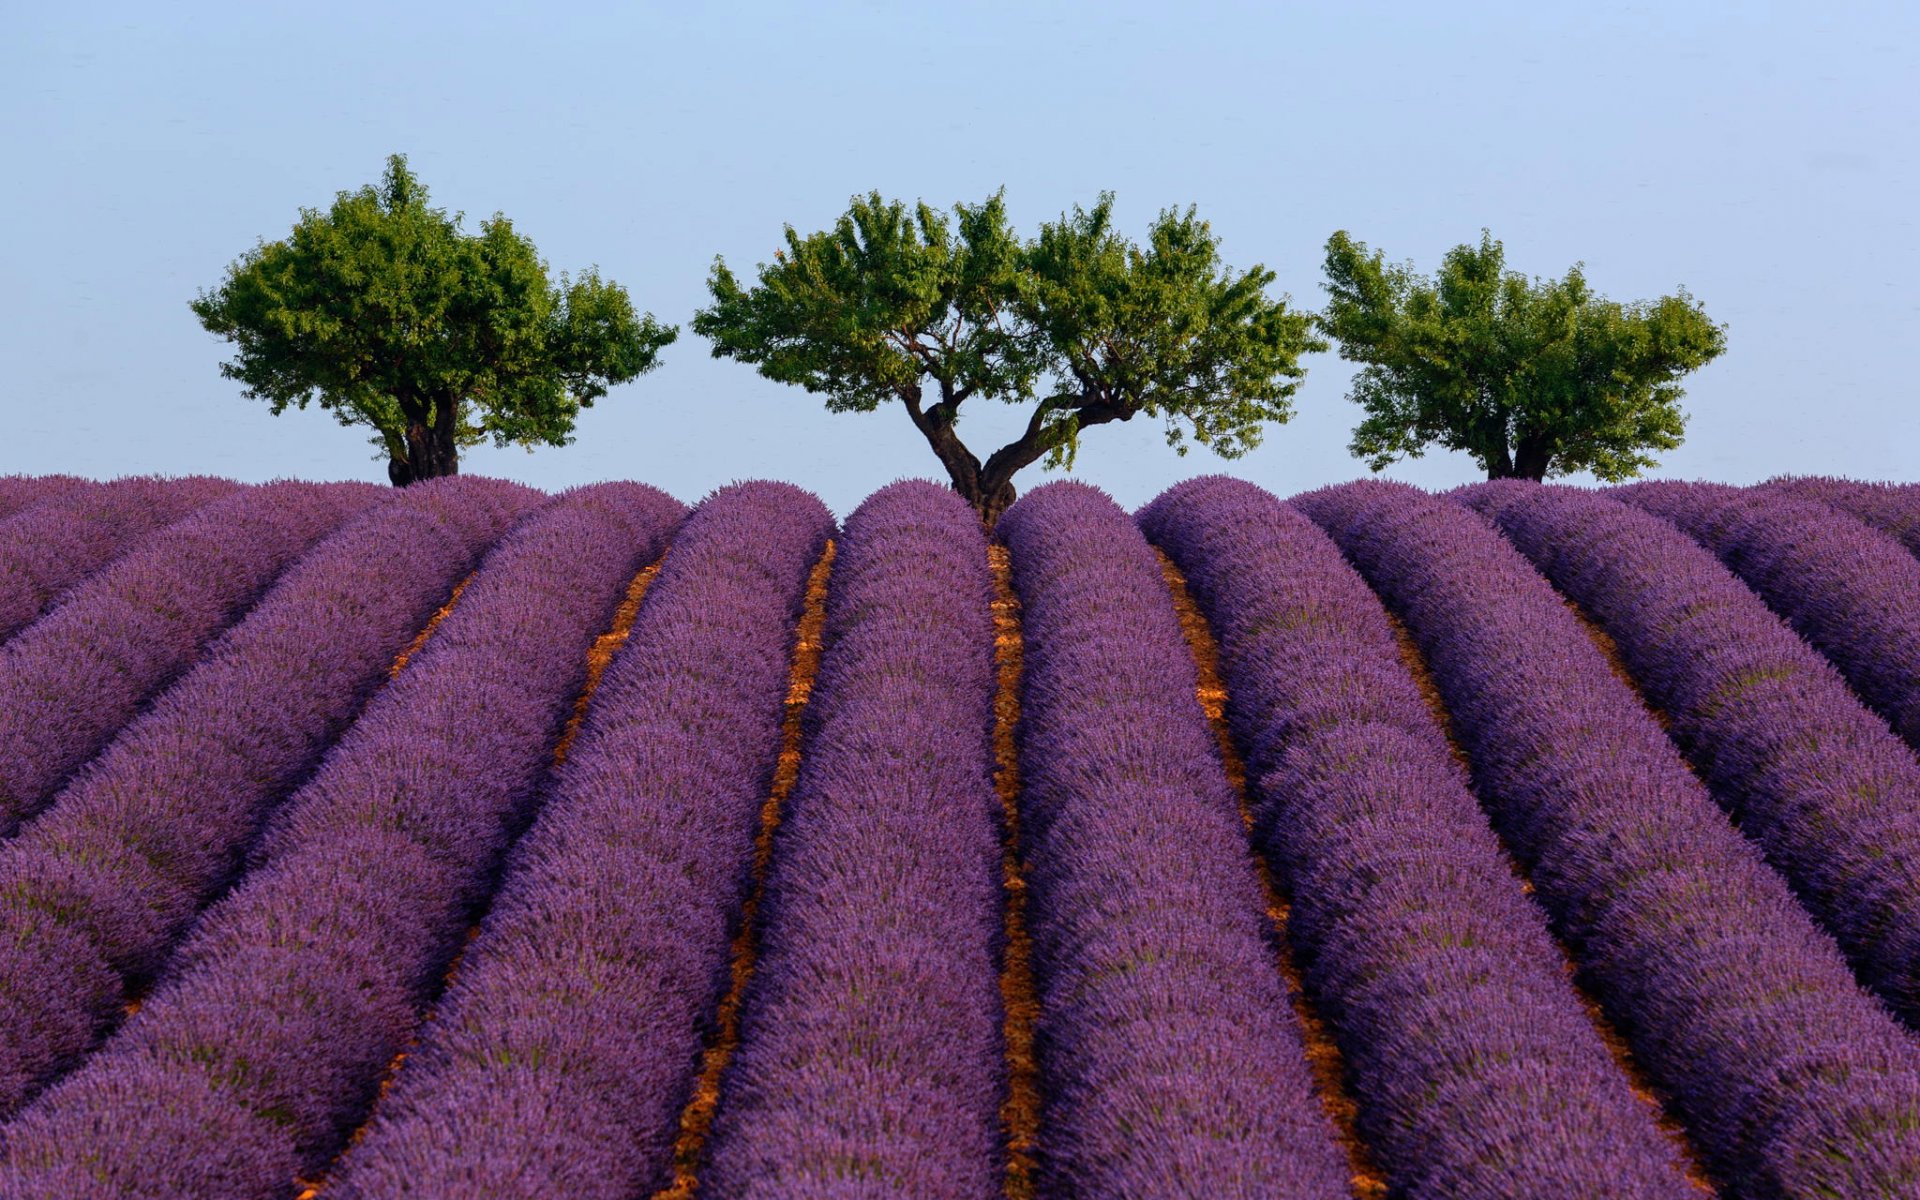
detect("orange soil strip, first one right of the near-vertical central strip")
(1154, 545), (1386, 1200)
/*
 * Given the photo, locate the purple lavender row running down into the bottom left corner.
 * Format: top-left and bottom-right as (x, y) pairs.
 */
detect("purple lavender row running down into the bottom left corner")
(4, 484), (684, 1200)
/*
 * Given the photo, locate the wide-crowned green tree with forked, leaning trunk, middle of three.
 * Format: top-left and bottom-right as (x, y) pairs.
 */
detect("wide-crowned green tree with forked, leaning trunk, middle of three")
(693, 192), (1325, 522)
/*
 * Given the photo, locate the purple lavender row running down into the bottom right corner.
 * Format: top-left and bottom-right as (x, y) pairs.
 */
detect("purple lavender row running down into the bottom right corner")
(1292, 482), (1920, 1198)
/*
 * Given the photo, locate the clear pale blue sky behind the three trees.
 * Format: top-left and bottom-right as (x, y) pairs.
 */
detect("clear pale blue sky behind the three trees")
(0, 0), (1920, 513)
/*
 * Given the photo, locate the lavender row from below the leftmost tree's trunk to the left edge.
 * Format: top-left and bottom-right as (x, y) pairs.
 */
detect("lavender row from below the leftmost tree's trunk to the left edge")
(0, 476), (536, 1114)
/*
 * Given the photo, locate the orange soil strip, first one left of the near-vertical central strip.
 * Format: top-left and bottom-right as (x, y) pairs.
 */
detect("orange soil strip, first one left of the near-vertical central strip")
(653, 541), (835, 1200)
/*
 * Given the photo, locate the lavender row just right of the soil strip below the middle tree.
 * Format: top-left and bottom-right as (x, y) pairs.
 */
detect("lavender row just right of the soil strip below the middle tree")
(998, 482), (1348, 1198)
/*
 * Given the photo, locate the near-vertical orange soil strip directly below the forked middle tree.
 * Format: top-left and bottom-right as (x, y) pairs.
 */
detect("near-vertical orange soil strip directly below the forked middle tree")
(987, 545), (1041, 1200)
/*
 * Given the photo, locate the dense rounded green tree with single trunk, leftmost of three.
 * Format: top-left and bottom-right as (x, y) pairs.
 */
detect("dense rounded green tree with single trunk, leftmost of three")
(192, 154), (678, 486)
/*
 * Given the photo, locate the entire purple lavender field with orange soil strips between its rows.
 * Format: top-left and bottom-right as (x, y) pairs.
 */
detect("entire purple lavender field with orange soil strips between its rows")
(0, 476), (1920, 1200)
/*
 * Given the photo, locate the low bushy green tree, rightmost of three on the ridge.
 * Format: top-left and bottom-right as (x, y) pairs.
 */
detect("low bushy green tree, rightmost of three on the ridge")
(1321, 230), (1726, 482)
